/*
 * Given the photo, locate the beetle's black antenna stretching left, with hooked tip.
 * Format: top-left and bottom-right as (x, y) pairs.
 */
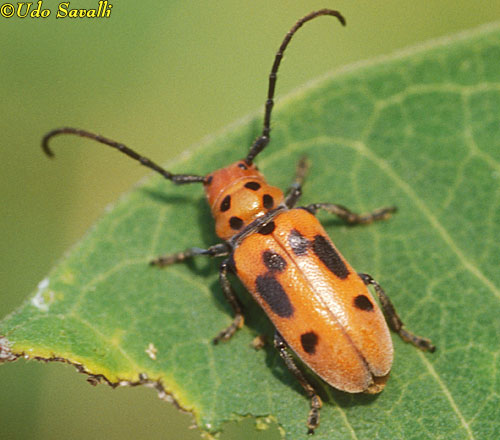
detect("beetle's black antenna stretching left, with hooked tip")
(42, 127), (205, 184)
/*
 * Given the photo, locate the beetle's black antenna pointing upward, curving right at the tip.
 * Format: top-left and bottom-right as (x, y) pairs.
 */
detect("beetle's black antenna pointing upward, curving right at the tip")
(245, 9), (345, 165)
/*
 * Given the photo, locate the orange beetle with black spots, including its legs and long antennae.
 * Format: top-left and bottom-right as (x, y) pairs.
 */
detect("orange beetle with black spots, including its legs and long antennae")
(42, 9), (435, 434)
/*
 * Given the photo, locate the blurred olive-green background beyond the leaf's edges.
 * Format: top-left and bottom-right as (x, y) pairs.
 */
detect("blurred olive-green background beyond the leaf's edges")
(0, 0), (500, 440)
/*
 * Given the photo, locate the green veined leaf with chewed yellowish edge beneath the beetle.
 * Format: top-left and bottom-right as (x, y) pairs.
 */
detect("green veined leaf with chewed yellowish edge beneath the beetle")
(0, 22), (500, 440)
